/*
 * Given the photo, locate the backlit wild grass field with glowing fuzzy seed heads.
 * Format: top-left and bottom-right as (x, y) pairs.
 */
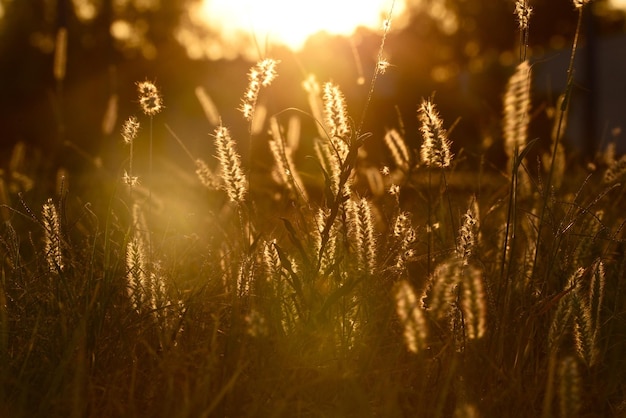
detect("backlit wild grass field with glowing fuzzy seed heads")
(0, 0), (626, 418)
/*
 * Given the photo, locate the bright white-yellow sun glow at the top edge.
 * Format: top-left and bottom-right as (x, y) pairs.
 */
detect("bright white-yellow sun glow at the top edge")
(182, 0), (406, 59)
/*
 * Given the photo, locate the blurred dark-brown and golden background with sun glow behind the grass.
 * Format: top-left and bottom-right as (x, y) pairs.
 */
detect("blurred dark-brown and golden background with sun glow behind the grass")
(0, 0), (626, 198)
